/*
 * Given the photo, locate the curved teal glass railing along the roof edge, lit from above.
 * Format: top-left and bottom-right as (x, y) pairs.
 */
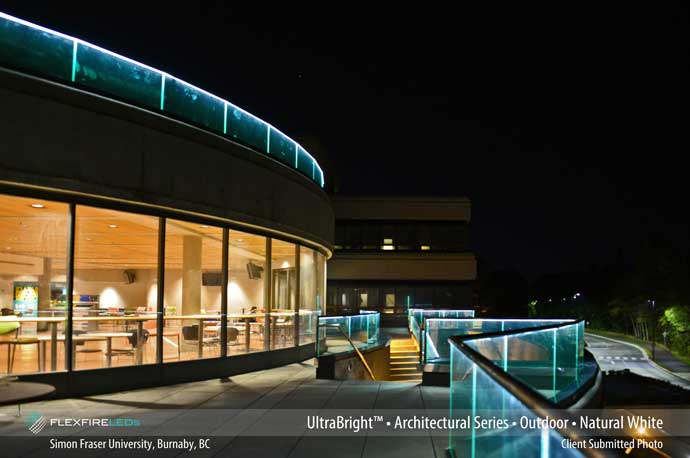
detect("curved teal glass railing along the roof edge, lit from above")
(0, 12), (324, 187)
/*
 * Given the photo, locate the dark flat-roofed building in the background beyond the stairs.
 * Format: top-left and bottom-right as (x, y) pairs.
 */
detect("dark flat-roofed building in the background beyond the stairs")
(327, 196), (477, 322)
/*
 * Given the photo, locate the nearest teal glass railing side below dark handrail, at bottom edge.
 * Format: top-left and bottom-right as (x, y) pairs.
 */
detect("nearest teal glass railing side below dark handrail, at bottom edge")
(448, 345), (582, 458)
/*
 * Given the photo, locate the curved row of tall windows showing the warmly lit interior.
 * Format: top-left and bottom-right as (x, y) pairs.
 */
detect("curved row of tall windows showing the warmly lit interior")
(0, 194), (326, 374)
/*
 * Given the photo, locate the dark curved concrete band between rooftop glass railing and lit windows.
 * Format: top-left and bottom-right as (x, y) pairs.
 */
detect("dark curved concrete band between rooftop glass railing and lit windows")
(0, 69), (333, 252)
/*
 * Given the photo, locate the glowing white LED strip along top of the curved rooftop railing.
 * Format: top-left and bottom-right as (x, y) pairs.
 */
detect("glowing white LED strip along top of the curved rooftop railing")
(0, 11), (324, 187)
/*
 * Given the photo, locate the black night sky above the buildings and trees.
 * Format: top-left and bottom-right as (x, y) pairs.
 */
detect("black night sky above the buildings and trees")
(0, 1), (690, 278)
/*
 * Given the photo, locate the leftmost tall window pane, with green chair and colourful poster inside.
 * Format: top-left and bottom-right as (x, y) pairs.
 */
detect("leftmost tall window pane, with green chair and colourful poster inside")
(0, 195), (68, 374)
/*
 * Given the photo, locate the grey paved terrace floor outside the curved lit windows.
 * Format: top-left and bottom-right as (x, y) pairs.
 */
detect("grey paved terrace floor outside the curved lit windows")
(0, 361), (448, 458)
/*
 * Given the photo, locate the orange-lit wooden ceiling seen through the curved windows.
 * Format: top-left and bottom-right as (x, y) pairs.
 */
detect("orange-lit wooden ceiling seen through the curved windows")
(0, 195), (304, 271)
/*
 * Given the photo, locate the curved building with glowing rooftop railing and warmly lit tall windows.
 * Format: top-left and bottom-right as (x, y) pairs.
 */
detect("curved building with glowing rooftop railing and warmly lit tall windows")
(0, 13), (333, 395)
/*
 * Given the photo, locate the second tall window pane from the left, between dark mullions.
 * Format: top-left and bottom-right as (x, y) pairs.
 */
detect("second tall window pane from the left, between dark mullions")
(72, 205), (158, 369)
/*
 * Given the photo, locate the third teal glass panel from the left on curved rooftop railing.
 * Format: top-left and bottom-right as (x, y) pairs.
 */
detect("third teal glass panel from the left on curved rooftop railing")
(163, 76), (225, 133)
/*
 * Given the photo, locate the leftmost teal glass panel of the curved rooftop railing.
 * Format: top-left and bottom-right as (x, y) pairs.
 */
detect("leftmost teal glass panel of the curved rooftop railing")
(0, 13), (74, 81)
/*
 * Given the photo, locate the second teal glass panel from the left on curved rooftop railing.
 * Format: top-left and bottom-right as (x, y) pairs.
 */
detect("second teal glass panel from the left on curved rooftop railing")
(75, 44), (163, 110)
